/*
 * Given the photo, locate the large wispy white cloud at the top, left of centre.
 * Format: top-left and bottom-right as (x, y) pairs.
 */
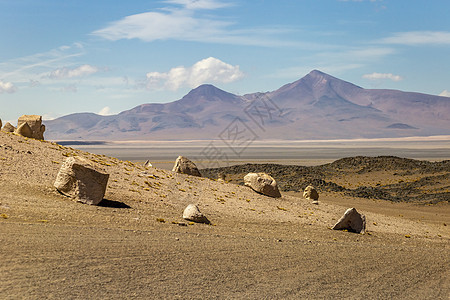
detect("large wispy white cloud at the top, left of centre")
(92, 0), (303, 47)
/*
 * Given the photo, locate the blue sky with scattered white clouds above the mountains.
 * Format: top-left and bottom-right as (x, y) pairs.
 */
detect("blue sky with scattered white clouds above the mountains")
(0, 0), (450, 123)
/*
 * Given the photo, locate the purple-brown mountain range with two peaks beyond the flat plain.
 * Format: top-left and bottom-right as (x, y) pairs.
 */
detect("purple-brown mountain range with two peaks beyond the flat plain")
(45, 70), (450, 141)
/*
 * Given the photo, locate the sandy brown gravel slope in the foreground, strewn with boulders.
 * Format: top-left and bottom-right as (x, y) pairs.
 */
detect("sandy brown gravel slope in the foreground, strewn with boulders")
(0, 132), (450, 299)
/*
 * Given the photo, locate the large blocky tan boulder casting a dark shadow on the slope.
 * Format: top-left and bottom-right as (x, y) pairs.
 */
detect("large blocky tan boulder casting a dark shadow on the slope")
(54, 157), (109, 205)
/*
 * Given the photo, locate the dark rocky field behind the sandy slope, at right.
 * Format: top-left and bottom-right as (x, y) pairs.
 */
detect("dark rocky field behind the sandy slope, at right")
(202, 156), (450, 204)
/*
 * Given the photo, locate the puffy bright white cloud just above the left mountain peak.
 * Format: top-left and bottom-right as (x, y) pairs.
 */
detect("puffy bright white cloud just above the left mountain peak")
(146, 57), (244, 90)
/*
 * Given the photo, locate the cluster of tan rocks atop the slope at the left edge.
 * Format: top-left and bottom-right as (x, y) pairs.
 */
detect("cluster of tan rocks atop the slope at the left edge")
(0, 115), (45, 140)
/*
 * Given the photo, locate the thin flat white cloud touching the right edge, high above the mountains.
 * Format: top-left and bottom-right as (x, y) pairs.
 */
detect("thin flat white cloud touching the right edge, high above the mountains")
(380, 31), (450, 46)
